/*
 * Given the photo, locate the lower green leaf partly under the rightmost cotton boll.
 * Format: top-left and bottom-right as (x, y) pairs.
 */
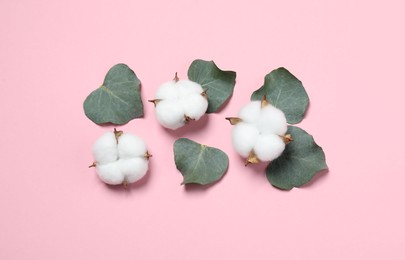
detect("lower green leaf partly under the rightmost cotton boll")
(266, 126), (328, 190)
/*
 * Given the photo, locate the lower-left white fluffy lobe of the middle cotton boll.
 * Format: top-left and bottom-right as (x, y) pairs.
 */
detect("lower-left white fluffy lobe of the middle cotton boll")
(156, 100), (185, 130)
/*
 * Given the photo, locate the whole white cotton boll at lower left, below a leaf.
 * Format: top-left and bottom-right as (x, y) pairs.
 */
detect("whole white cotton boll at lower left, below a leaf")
(90, 128), (151, 187)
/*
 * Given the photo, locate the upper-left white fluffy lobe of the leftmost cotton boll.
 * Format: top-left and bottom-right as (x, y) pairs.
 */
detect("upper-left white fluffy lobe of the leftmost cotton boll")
(93, 132), (118, 164)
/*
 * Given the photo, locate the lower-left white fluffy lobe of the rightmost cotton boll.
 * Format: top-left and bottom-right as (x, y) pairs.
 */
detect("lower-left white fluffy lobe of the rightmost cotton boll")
(232, 122), (259, 157)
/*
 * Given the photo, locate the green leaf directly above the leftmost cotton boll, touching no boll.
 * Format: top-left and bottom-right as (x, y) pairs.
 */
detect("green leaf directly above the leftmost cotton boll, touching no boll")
(83, 64), (143, 125)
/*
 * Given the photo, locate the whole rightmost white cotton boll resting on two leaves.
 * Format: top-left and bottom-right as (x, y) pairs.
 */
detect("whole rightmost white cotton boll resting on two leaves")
(226, 96), (292, 165)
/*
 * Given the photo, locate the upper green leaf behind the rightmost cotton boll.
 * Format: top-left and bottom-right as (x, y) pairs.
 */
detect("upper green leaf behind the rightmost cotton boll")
(251, 68), (309, 124)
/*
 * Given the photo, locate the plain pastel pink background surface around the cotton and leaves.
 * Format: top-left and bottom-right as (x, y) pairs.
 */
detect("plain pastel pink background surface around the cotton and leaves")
(0, 0), (405, 259)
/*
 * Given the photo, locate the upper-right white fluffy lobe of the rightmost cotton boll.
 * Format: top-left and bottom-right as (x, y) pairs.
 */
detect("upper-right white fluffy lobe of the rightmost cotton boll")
(257, 105), (287, 136)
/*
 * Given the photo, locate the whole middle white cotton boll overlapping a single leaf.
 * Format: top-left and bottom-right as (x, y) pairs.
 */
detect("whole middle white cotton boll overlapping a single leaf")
(149, 73), (208, 130)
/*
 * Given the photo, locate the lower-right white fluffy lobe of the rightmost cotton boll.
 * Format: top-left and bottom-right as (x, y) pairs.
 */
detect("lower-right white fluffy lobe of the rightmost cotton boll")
(253, 134), (285, 161)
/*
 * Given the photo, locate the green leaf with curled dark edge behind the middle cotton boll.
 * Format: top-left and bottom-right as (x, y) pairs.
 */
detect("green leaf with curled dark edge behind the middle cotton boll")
(188, 60), (236, 113)
